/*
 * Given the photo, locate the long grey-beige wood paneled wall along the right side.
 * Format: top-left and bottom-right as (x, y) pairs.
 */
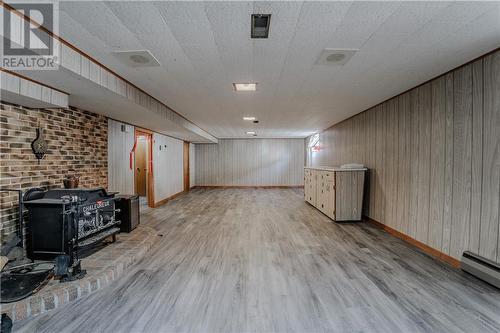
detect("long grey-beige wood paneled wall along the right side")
(310, 51), (500, 263)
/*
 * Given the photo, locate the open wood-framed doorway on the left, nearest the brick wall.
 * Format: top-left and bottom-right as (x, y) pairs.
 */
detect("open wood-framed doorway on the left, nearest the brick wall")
(134, 129), (154, 207)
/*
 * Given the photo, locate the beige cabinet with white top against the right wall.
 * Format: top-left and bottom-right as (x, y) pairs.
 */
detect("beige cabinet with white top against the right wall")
(304, 167), (367, 221)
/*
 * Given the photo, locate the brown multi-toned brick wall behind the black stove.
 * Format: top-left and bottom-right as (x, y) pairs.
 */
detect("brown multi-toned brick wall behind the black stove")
(0, 103), (108, 235)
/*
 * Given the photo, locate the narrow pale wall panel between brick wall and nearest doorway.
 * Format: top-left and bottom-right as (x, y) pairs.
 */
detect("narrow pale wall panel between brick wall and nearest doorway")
(108, 119), (135, 194)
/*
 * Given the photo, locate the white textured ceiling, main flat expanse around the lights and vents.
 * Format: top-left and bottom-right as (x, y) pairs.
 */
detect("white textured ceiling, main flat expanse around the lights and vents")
(47, 1), (500, 138)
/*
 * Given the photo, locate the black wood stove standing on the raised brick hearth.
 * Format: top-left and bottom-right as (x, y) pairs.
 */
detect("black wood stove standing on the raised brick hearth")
(24, 188), (120, 266)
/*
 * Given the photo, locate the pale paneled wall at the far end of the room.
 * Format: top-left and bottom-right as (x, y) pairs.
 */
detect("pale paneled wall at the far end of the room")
(195, 139), (304, 186)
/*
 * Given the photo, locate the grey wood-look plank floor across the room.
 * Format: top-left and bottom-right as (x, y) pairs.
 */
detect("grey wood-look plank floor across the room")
(15, 189), (500, 332)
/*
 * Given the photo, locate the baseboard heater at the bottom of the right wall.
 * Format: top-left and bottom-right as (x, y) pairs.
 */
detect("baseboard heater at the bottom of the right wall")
(462, 251), (500, 288)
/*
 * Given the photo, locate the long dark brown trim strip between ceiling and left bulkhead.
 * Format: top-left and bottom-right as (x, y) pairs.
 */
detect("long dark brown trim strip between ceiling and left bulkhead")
(2, 1), (218, 139)
